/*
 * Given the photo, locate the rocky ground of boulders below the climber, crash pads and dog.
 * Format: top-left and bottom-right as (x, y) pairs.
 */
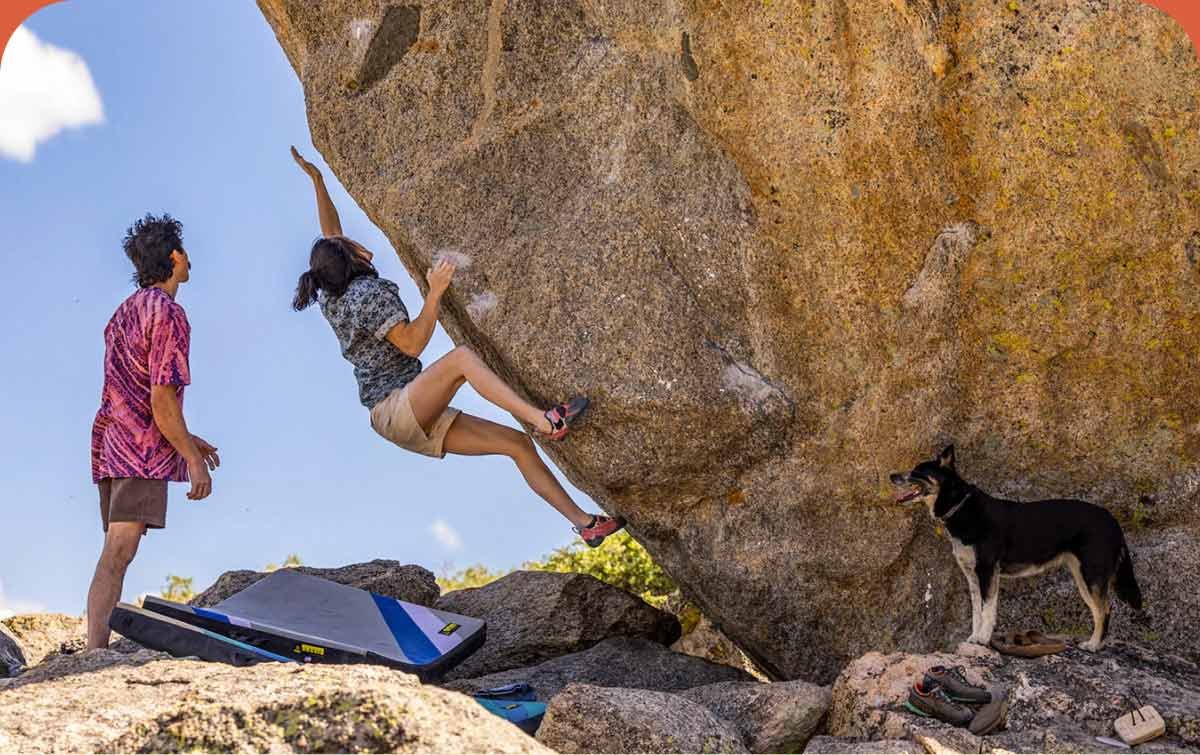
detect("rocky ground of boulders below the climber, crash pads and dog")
(0, 561), (1200, 753)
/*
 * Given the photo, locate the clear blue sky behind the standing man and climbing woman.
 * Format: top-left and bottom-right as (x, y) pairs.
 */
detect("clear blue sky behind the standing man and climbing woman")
(0, 0), (594, 613)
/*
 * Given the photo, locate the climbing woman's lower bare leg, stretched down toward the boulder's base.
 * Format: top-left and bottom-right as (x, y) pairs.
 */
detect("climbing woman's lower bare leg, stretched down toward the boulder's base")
(441, 412), (592, 527)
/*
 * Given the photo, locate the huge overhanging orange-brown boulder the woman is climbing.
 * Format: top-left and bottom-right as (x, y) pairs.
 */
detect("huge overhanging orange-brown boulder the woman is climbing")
(258, 0), (1200, 681)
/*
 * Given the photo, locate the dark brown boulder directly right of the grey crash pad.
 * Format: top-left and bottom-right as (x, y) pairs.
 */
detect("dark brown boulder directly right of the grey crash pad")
(437, 571), (679, 679)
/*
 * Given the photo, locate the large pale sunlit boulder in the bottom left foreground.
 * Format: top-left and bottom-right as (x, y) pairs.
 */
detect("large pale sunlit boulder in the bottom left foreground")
(0, 651), (548, 753)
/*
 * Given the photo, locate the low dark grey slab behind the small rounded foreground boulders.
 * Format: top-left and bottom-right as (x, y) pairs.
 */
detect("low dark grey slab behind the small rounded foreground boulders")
(445, 639), (754, 702)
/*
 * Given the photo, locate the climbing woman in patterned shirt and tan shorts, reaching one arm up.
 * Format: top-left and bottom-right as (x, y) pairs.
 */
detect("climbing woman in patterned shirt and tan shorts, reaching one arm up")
(292, 146), (625, 547)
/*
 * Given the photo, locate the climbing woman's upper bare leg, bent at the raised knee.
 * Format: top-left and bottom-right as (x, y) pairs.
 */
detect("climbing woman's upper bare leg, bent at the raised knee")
(408, 346), (552, 432)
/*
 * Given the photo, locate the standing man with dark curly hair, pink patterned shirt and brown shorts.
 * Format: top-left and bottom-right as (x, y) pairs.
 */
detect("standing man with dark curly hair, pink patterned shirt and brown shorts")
(88, 215), (221, 649)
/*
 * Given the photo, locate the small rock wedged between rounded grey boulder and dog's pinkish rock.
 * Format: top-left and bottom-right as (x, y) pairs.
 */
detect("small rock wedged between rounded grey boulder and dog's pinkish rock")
(679, 682), (829, 753)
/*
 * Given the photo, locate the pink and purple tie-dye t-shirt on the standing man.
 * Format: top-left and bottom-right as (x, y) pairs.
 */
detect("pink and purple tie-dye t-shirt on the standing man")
(91, 288), (192, 483)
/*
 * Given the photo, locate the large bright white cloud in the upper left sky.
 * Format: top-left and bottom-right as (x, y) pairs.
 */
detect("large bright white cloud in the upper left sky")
(0, 26), (104, 162)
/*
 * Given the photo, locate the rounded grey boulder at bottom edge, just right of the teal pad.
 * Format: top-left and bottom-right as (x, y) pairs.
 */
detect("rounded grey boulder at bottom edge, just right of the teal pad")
(538, 684), (746, 753)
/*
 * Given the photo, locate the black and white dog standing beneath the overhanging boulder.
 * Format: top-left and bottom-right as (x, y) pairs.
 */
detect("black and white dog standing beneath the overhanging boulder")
(892, 445), (1141, 652)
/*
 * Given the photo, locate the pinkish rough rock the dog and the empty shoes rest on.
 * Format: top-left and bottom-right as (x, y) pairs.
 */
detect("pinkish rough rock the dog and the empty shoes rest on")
(827, 642), (1200, 753)
